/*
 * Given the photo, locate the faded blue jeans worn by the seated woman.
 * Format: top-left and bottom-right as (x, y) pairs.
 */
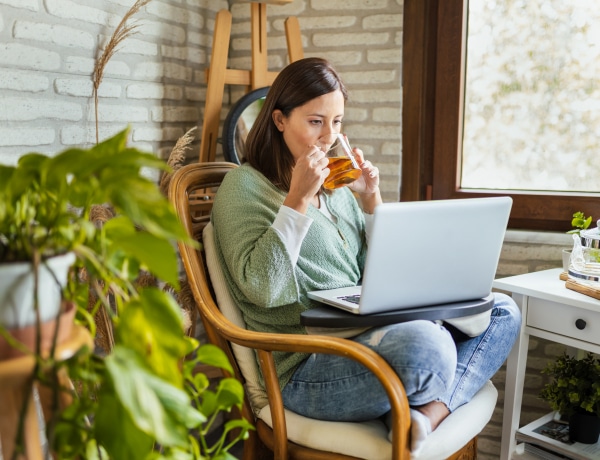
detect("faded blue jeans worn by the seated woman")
(282, 293), (521, 421)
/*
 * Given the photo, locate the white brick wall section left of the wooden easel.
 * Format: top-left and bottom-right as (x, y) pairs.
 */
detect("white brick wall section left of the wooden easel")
(0, 0), (228, 164)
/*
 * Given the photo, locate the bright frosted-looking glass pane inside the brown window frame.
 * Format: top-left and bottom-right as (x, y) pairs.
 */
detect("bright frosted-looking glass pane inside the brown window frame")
(461, 0), (600, 192)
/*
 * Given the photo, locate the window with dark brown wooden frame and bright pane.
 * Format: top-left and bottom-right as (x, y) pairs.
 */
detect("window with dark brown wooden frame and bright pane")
(401, 0), (600, 231)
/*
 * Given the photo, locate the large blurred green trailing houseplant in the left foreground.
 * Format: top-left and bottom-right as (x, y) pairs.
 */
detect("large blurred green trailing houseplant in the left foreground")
(0, 130), (251, 459)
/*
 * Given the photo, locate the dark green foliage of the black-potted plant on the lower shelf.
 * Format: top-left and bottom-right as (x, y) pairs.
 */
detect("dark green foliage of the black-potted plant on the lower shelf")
(540, 353), (600, 417)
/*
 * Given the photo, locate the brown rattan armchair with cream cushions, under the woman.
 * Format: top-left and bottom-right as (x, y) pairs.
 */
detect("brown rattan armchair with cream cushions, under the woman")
(169, 162), (497, 460)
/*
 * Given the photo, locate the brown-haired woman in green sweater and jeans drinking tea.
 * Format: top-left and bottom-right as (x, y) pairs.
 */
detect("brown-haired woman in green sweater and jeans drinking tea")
(212, 58), (520, 452)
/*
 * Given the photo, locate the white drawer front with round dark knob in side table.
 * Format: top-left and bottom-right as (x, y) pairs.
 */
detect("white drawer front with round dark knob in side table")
(527, 297), (600, 343)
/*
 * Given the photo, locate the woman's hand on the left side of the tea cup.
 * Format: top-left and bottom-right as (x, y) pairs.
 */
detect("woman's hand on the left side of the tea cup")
(283, 145), (329, 214)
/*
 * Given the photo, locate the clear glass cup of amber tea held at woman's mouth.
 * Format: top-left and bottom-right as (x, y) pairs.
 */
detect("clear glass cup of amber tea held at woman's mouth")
(317, 133), (362, 190)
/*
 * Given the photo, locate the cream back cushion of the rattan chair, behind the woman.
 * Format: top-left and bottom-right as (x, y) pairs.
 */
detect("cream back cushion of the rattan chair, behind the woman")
(202, 222), (269, 415)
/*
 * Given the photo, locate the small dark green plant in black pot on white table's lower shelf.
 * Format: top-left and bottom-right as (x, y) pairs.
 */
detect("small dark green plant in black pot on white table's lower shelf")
(540, 353), (600, 444)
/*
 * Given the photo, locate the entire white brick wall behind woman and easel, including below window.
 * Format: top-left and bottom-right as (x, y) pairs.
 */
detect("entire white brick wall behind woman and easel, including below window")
(0, 0), (570, 460)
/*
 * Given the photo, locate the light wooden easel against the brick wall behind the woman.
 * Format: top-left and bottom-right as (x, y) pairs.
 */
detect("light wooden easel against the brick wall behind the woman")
(200, 0), (304, 163)
